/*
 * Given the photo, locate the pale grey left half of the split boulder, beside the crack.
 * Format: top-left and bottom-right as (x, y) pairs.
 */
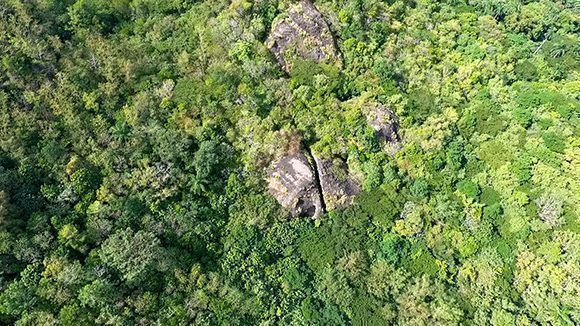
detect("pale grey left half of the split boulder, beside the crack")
(268, 153), (324, 218)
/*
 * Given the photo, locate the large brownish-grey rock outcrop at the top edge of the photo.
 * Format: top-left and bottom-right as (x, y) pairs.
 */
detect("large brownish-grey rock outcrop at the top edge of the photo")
(266, 1), (340, 72)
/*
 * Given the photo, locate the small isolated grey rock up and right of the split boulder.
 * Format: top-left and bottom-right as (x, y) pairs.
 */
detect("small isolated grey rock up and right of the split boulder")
(366, 104), (401, 154)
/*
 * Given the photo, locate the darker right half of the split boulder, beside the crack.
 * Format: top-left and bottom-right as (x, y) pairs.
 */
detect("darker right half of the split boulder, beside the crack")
(313, 155), (361, 210)
